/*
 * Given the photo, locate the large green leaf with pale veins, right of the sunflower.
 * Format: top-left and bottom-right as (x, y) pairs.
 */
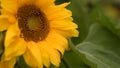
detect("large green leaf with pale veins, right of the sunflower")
(76, 24), (120, 68)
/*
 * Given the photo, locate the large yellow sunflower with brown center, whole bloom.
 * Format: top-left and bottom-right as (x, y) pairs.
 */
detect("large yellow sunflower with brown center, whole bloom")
(0, 0), (78, 68)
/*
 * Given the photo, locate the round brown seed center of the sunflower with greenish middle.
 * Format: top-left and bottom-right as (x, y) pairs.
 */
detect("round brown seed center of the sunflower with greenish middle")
(17, 5), (49, 42)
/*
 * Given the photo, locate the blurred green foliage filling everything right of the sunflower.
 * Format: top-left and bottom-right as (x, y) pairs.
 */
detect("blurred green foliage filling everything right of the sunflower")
(56, 0), (120, 68)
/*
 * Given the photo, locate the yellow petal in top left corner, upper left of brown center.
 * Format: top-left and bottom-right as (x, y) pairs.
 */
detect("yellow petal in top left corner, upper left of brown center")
(1, 0), (18, 13)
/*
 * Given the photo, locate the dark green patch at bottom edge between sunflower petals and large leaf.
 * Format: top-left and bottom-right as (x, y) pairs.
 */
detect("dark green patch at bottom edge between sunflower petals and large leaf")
(60, 50), (90, 68)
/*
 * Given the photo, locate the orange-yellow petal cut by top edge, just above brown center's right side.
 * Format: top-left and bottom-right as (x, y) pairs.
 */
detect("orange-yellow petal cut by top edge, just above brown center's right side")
(36, 0), (55, 9)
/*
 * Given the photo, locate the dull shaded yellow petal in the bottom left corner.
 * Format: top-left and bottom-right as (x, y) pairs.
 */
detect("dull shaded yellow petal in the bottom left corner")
(0, 58), (16, 68)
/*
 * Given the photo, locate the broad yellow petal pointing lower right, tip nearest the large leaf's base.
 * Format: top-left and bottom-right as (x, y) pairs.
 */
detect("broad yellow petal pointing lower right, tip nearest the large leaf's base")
(46, 31), (68, 55)
